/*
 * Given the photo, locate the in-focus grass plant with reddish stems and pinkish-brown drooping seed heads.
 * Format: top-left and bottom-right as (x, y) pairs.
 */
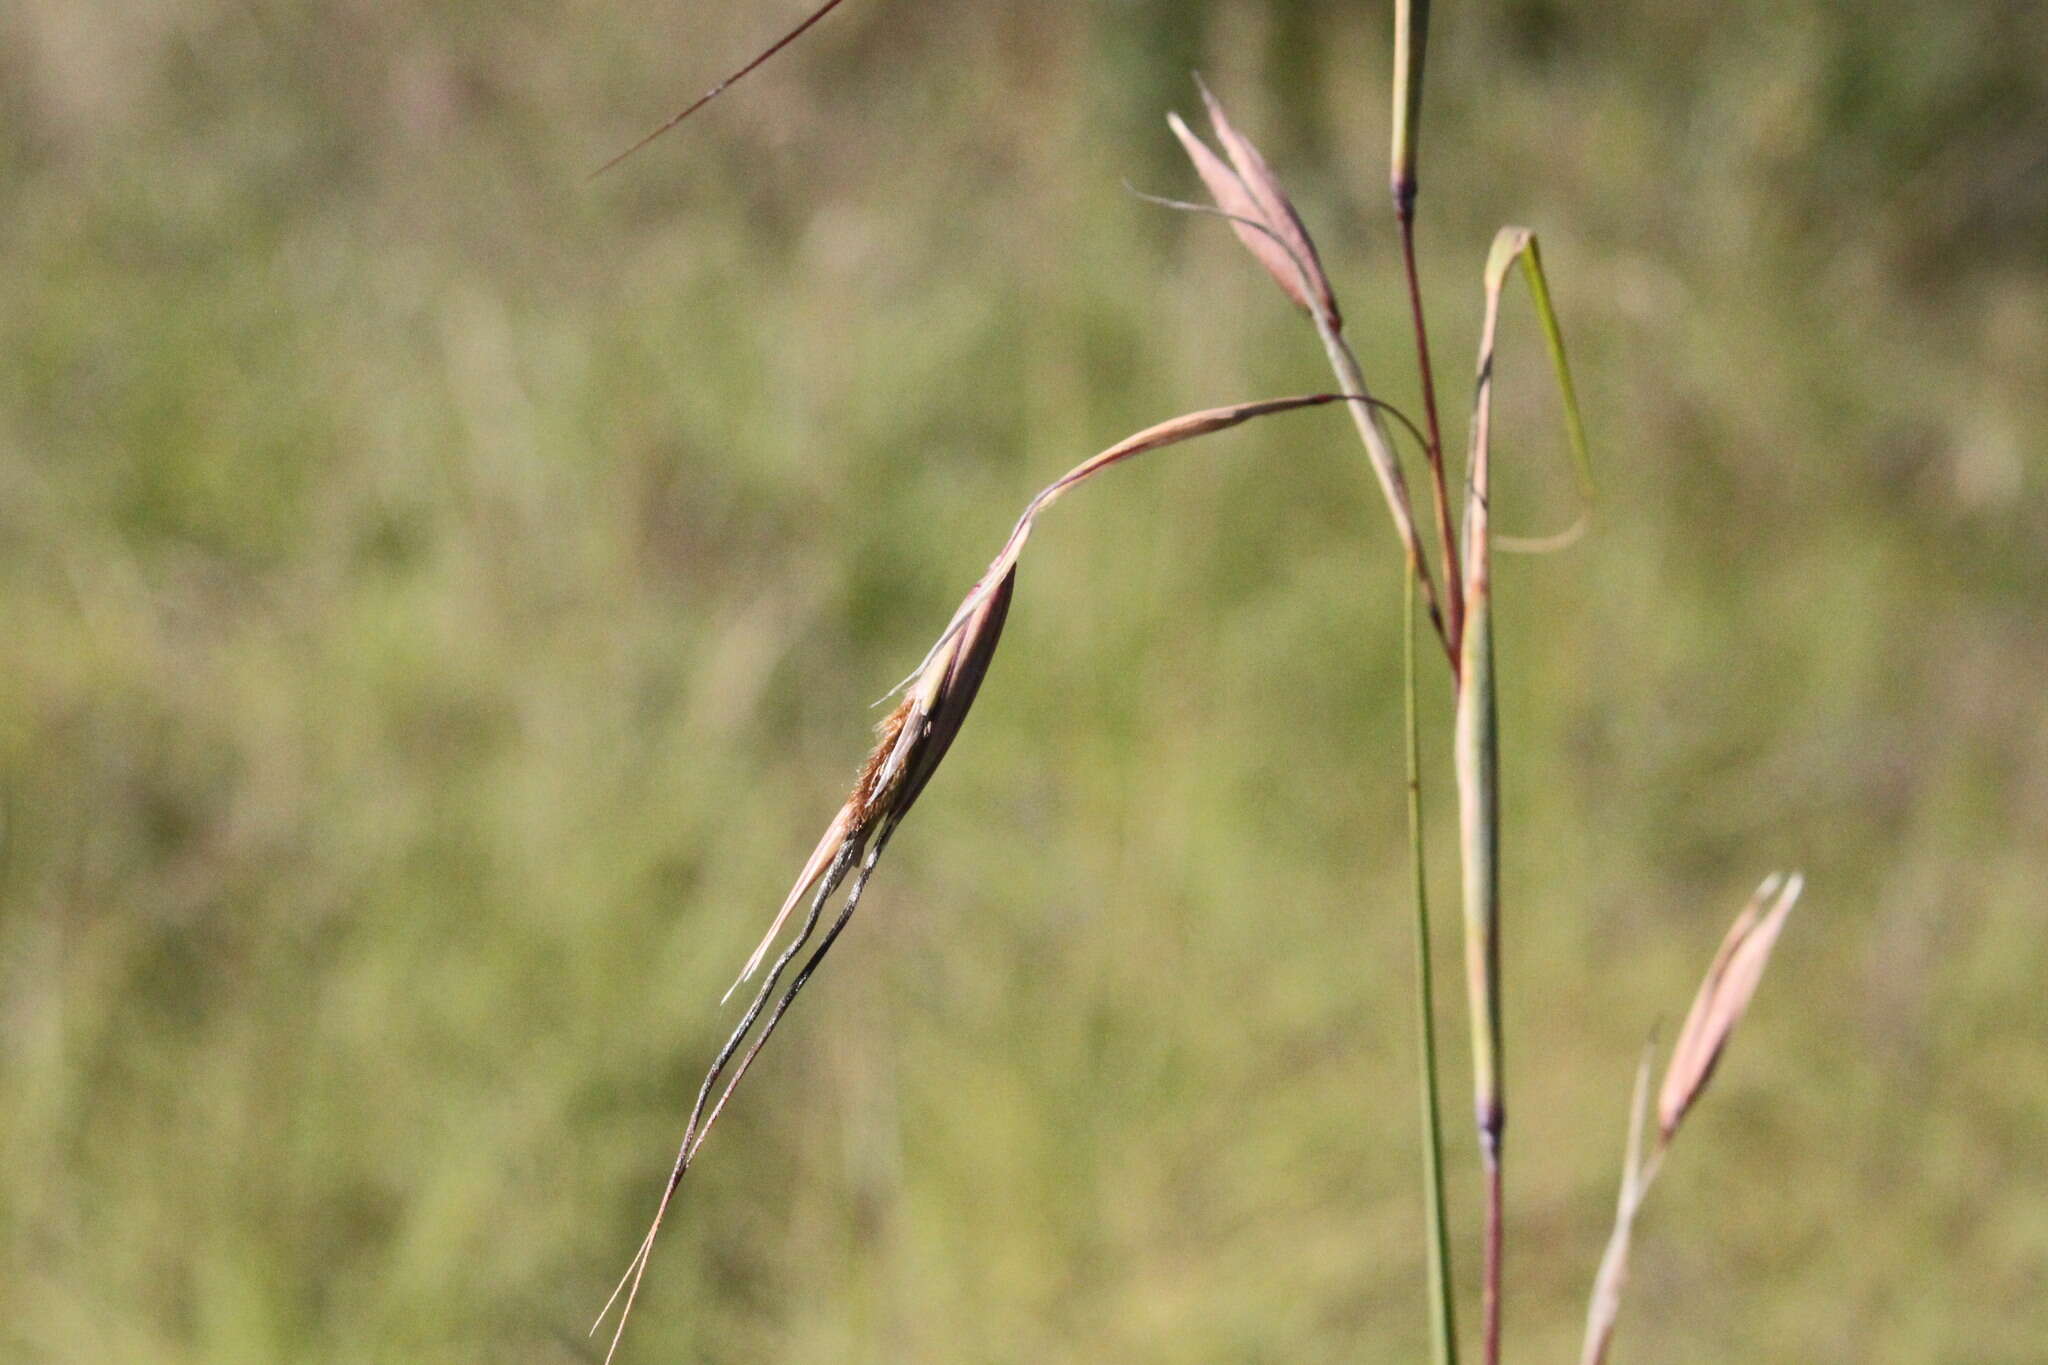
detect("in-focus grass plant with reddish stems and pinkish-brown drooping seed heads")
(592, 0), (1800, 1365)
